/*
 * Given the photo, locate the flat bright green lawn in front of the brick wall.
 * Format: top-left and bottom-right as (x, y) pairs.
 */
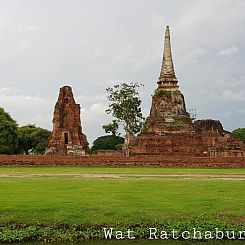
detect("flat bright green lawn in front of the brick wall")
(0, 167), (245, 224)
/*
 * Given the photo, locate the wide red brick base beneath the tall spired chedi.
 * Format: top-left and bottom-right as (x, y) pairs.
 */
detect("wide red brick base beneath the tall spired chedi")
(130, 131), (245, 157)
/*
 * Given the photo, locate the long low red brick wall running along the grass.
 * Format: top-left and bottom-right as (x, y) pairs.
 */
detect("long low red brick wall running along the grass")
(0, 155), (245, 168)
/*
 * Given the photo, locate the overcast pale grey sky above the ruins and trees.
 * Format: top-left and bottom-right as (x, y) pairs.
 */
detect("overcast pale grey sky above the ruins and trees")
(0, 0), (245, 143)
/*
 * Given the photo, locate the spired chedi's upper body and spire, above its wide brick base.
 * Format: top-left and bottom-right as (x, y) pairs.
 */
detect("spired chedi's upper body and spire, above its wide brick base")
(145, 26), (192, 134)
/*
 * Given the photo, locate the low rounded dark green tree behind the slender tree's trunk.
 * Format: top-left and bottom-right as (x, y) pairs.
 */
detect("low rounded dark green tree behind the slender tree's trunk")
(91, 135), (124, 151)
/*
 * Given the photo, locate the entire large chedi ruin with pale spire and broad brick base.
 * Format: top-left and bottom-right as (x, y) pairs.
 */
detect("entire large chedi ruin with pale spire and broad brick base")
(130, 26), (245, 157)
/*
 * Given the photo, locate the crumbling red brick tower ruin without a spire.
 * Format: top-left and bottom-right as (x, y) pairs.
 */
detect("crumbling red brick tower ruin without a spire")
(46, 86), (89, 156)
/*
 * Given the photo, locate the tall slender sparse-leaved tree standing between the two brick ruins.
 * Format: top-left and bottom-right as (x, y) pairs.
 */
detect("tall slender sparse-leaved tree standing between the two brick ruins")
(106, 83), (144, 156)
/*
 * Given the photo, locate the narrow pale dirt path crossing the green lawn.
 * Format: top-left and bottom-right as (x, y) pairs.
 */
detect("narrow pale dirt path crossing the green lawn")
(0, 173), (245, 180)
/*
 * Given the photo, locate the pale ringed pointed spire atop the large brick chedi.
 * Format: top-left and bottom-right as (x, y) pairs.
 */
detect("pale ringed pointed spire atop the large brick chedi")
(157, 26), (178, 90)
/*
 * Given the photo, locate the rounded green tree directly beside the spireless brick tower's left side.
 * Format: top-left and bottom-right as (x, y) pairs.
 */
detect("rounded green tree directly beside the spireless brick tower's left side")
(18, 124), (50, 154)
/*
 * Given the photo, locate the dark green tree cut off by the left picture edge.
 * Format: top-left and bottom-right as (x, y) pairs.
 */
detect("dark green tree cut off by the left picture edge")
(0, 107), (18, 154)
